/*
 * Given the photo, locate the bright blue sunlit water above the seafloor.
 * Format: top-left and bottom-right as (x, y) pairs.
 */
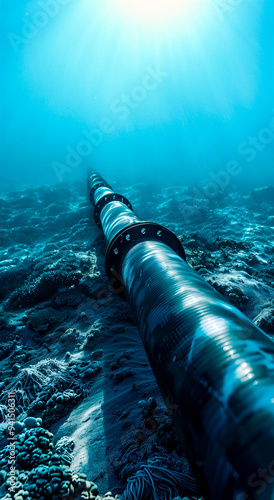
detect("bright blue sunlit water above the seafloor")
(0, 0), (274, 189)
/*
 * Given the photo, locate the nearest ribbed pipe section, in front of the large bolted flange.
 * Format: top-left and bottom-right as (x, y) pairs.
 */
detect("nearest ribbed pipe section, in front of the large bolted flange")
(122, 241), (274, 500)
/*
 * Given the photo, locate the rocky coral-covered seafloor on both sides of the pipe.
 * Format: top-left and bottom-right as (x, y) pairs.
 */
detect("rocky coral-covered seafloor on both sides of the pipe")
(0, 183), (274, 500)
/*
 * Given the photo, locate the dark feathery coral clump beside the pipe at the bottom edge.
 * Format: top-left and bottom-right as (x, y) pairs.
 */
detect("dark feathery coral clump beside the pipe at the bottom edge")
(114, 397), (197, 500)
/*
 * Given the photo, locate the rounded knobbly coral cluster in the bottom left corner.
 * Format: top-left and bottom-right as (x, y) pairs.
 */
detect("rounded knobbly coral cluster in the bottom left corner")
(0, 419), (99, 500)
